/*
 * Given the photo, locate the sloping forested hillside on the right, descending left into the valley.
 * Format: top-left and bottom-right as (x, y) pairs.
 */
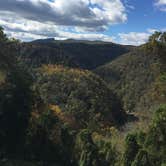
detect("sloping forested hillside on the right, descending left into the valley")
(95, 33), (166, 112)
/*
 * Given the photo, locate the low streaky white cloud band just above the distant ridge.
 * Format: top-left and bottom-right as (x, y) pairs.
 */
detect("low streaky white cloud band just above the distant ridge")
(0, 12), (114, 42)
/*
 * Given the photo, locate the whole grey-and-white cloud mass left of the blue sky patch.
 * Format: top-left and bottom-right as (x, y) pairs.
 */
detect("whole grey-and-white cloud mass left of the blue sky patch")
(0, 0), (127, 41)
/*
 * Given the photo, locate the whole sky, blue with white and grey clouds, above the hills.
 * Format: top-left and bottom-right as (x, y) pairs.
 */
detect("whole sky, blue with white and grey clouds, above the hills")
(0, 0), (166, 45)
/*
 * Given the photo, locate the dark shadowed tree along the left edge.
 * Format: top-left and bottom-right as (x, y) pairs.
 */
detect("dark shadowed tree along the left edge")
(0, 28), (33, 153)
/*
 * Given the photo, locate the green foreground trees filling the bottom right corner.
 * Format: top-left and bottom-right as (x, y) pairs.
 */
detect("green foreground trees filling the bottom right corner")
(124, 105), (166, 166)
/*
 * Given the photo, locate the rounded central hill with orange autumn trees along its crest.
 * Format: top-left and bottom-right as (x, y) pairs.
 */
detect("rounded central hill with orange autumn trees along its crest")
(36, 65), (125, 127)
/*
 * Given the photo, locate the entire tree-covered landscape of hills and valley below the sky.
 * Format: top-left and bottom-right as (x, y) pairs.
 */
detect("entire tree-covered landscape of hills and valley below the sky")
(0, 28), (166, 166)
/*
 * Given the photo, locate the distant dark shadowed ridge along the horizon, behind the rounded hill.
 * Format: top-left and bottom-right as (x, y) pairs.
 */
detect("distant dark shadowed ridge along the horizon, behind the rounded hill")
(20, 39), (134, 69)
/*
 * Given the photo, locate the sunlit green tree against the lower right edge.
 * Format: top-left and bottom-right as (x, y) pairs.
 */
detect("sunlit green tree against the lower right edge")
(145, 105), (166, 165)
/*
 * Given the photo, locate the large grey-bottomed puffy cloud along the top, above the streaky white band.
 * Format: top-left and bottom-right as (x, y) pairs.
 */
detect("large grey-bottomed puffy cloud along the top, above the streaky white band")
(0, 0), (127, 31)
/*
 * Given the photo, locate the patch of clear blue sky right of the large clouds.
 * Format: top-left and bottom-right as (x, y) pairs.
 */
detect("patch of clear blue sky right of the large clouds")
(105, 0), (166, 45)
